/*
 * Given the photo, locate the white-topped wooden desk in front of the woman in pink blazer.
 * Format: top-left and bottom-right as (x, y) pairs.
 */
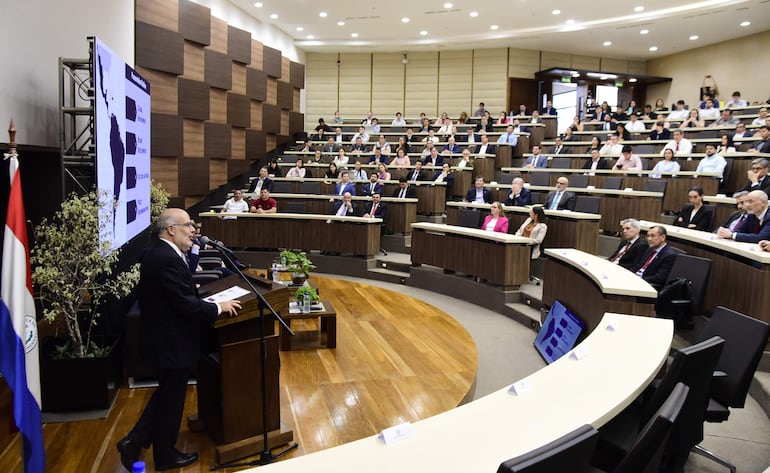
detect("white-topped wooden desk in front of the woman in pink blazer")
(412, 223), (532, 290)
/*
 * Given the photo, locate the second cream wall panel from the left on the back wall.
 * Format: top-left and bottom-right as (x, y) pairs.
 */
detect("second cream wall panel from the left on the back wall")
(338, 53), (372, 121)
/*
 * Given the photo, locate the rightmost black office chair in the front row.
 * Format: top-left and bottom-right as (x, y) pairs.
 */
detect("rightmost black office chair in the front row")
(693, 306), (770, 473)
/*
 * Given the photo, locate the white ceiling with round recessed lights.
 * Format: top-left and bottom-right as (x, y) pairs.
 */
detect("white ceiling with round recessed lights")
(230, 0), (770, 60)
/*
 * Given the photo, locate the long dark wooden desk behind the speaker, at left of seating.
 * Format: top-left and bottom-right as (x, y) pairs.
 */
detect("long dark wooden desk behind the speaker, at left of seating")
(198, 212), (382, 256)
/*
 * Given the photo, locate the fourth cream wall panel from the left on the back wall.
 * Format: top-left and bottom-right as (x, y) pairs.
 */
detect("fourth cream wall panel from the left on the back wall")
(404, 52), (438, 118)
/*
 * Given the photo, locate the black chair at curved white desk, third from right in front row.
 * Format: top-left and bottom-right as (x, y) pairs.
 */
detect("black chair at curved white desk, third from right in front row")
(591, 383), (690, 473)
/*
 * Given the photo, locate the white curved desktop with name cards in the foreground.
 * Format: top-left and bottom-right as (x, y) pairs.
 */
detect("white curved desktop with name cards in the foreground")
(248, 313), (673, 473)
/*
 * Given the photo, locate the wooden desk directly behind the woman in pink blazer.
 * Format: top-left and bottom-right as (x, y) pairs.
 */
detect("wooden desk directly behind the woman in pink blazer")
(446, 202), (601, 254)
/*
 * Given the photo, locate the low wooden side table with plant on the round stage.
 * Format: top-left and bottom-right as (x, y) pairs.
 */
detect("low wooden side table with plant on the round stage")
(280, 301), (337, 351)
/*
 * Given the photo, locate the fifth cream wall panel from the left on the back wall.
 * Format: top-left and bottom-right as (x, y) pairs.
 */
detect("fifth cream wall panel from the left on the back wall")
(438, 51), (472, 118)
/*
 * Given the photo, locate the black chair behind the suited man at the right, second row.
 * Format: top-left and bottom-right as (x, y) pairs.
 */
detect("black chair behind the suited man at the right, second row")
(655, 253), (711, 328)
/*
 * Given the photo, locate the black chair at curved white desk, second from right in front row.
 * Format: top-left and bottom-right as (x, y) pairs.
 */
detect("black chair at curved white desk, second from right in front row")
(597, 337), (724, 472)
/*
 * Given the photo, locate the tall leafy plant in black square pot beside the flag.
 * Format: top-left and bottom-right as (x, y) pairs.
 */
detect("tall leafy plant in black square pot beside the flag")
(30, 192), (139, 411)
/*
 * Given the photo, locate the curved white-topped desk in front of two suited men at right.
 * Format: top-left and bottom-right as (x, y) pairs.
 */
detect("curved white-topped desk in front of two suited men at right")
(542, 248), (658, 330)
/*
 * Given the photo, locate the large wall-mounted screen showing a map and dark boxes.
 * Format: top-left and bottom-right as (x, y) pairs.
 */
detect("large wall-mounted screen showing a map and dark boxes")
(94, 38), (150, 249)
